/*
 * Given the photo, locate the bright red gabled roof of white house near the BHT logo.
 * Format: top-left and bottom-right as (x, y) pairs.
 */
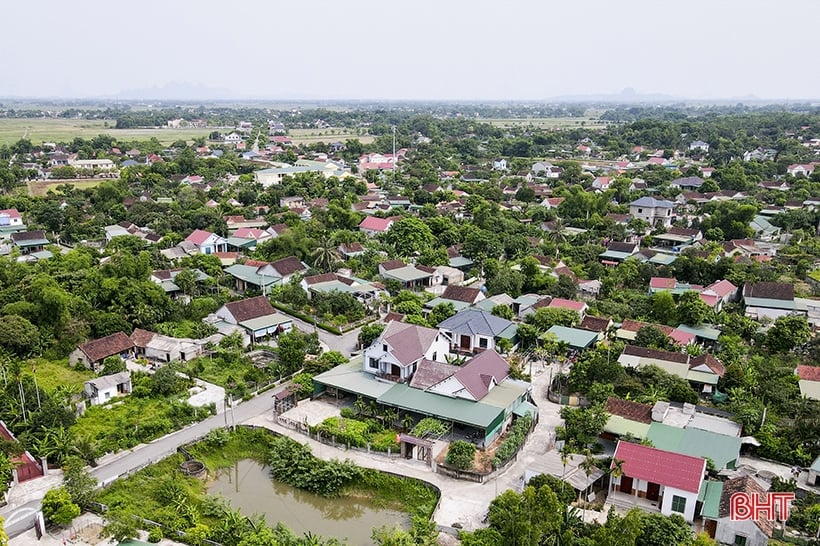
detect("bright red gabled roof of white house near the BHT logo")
(613, 440), (706, 493)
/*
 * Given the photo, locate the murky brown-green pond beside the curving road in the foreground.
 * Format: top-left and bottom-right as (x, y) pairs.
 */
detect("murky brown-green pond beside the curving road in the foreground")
(208, 459), (410, 546)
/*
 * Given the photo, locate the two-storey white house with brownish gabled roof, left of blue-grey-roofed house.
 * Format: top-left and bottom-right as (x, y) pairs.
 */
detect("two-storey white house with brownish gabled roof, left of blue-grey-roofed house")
(362, 320), (450, 383)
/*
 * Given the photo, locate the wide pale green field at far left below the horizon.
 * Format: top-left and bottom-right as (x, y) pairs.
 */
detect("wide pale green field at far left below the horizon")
(0, 118), (214, 144)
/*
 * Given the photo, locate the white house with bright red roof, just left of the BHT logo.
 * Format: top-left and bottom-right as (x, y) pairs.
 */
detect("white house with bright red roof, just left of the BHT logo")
(610, 440), (706, 522)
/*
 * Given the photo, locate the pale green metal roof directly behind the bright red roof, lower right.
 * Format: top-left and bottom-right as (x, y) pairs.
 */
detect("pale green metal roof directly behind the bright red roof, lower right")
(647, 423), (740, 470)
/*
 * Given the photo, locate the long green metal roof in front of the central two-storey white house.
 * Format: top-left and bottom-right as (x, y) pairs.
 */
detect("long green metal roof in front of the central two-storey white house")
(377, 383), (504, 430)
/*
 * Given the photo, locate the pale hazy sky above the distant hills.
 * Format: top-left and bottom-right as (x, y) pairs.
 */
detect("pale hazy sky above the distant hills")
(0, 0), (820, 100)
